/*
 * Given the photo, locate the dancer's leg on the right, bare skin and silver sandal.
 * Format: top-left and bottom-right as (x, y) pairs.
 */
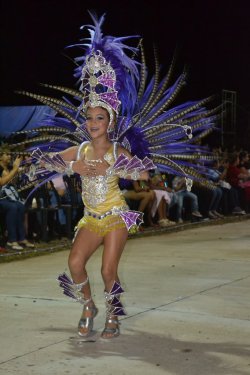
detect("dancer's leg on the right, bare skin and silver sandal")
(102, 228), (128, 338)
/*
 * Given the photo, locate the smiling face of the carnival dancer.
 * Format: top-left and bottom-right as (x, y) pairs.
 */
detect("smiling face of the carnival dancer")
(86, 107), (109, 138)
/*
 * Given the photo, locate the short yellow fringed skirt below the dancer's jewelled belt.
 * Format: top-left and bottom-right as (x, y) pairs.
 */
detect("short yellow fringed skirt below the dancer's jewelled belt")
(76, 215), (126, 237)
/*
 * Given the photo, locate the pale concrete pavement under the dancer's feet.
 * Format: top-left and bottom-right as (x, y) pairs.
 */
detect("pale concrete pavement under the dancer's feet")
(0, 218), (250, 375)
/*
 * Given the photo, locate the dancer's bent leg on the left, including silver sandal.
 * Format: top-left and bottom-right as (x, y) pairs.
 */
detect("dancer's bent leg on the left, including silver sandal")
(68, 228), (103, 336)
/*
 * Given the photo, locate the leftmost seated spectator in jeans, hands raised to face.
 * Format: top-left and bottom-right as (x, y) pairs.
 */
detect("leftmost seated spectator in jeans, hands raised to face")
(0, 151), (34, 250)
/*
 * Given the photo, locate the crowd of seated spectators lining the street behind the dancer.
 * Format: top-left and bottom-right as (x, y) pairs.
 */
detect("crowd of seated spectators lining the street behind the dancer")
(0, 145), (250, 254)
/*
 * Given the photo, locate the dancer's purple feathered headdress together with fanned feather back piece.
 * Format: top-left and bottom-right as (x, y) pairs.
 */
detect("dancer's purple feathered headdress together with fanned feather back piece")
(12, 14), (217, 191)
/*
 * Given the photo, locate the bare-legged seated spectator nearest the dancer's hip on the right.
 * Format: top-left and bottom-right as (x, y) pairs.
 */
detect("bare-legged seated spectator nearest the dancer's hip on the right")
(122, 180), (155, 226)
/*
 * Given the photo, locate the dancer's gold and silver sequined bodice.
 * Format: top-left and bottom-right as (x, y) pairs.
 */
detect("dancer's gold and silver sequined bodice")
(79, 143), (126, 214)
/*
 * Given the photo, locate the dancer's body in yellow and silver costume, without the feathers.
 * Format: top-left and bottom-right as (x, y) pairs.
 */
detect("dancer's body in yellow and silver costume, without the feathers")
(58, 106), (148, 338)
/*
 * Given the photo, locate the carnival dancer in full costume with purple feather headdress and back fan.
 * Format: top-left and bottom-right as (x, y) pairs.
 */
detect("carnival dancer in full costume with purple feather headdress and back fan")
(10, 15), (216, 339)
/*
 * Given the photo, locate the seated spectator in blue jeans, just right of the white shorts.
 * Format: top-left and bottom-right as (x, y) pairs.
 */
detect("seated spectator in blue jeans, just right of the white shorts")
(172, 176), (203, 223)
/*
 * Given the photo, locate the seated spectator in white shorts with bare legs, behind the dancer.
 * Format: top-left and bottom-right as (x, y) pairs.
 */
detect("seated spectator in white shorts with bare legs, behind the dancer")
(149, 172), (175, 227)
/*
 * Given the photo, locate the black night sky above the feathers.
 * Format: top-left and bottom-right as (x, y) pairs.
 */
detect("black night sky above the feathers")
(0, 0), (250, 111)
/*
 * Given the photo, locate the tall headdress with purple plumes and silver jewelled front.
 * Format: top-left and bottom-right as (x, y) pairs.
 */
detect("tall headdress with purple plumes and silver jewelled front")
(71, 13), (139, 123)
